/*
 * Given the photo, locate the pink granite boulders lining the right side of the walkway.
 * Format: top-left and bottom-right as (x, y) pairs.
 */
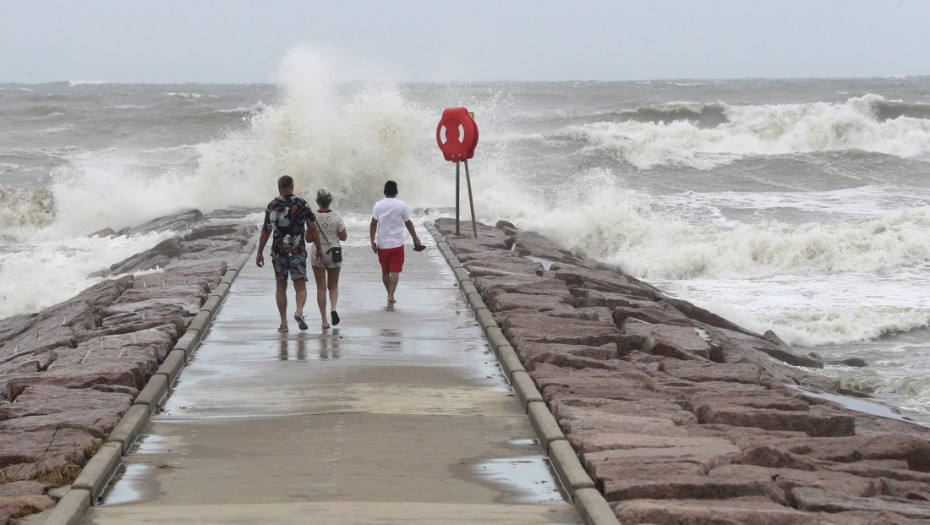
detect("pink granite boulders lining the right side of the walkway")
(435, 219), (930, 525)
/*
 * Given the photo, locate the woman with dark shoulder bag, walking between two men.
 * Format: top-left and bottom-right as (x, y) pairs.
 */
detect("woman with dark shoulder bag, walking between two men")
(311, 188), (346, 330)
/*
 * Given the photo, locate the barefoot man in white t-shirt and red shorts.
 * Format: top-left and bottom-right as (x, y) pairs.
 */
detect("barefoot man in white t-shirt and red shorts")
(369, 180), (420, 303)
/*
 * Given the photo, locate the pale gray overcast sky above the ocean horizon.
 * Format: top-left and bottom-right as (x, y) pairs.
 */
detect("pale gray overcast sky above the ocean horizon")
(0, 0), (930, 83)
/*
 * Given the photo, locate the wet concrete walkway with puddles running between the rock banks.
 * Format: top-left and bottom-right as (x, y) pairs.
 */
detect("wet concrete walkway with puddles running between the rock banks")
(84, 222), (582, 525)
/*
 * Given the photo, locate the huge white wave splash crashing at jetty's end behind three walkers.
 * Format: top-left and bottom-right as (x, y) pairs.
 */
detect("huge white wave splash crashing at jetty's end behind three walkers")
(0, 49), (450, 239)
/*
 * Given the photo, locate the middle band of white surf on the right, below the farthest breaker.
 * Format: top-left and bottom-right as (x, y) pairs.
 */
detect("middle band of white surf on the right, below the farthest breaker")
(513, 189), (930, 279)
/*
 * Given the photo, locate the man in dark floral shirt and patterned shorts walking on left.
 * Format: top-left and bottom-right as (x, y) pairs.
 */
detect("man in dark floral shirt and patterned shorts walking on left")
(255, 175), (323, 332)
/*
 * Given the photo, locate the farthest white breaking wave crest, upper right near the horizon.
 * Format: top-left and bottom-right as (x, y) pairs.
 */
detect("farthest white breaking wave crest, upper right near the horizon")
(563, 95), (930, 169)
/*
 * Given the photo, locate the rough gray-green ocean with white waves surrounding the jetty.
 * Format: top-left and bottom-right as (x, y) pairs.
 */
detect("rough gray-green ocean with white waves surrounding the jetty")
(0, 55), (930, 424)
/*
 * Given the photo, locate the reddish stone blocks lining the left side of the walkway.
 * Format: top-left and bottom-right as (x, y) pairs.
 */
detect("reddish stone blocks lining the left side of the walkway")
(0, 210), (256, 525)
